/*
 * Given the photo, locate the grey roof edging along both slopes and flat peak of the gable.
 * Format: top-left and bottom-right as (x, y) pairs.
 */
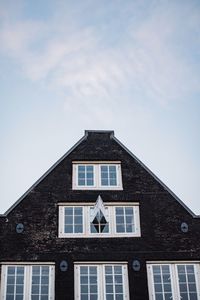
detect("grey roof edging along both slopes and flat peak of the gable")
(0, 130), (200, 218)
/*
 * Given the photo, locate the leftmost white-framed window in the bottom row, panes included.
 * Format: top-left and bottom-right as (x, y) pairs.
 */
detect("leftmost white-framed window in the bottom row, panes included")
(2, 265), (54, 300)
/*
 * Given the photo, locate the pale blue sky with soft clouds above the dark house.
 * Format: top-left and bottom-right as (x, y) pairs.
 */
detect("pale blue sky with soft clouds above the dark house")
(0, 0), (200, 215)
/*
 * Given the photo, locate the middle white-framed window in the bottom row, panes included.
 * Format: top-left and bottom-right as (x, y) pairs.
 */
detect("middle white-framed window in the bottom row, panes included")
(75, 263), (129, 300)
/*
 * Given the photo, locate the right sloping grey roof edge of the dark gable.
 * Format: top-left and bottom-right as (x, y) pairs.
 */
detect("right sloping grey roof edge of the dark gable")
(113, 136), (200, 218)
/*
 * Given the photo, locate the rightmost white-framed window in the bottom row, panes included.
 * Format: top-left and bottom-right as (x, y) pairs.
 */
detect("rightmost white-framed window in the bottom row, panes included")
(147, 262), (200, 300)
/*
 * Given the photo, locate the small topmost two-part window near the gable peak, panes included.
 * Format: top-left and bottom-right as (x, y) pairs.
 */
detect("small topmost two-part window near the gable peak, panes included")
(73, 162), (122, 190)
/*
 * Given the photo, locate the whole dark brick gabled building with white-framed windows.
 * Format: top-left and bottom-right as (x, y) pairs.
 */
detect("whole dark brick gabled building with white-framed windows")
(0, 131), (200, 300)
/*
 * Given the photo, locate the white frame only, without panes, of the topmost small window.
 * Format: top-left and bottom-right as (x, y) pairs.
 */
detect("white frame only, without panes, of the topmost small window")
(72, 161), (123, 190)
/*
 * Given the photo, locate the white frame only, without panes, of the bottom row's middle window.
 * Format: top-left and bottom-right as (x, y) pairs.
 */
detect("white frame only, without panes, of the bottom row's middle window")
(74, 262), (129, 300)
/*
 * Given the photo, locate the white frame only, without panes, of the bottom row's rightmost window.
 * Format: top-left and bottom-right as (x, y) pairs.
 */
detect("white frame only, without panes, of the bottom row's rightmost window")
(147, 261), (200, 300)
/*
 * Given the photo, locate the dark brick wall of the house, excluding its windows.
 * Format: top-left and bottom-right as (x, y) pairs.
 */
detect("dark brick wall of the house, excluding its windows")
(0, 132), (200, 300)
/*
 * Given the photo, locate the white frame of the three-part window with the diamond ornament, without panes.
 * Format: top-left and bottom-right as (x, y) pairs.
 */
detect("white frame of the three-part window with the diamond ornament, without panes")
(58, 202), (141, 238)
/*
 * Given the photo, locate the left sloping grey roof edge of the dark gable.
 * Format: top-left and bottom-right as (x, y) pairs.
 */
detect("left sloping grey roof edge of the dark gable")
(0, 130), (88, 217)
